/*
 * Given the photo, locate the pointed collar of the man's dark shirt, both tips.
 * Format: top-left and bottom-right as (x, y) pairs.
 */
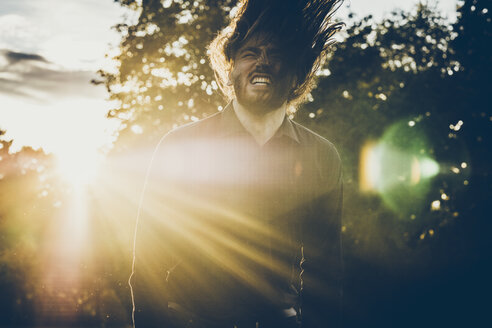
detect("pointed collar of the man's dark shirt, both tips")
(219, 102), (300, 143)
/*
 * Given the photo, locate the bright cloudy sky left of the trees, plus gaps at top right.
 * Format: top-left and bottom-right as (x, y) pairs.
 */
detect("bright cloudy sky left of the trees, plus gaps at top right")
(0, 0), (457, 157)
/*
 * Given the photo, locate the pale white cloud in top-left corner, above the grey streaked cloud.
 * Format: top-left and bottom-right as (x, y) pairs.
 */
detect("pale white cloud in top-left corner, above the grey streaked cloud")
(0, 0), (131, 71)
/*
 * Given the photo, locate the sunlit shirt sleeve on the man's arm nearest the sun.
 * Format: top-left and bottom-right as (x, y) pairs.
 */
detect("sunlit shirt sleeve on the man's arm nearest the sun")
(131, 135), (181, 328)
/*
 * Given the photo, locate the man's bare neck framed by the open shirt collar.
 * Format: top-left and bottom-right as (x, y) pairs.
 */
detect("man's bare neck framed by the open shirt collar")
(232, 100), (285, 146)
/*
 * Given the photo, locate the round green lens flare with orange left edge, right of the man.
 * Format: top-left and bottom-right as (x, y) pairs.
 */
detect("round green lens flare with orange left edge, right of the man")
(359, 120), (441, 214)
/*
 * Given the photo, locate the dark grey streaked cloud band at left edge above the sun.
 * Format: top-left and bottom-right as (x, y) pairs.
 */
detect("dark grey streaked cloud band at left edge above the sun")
(0, 49), (105, 102)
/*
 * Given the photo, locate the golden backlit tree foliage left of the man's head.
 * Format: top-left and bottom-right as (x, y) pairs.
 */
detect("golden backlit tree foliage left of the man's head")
(96, 0), (235, 148)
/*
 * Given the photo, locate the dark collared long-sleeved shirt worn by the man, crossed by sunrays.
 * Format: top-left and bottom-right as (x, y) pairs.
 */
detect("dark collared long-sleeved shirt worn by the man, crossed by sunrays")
(133, 105), (342, 327)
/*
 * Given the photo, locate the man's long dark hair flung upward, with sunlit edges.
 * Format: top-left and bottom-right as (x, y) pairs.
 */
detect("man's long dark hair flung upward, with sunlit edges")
(208, 0), (343, 107)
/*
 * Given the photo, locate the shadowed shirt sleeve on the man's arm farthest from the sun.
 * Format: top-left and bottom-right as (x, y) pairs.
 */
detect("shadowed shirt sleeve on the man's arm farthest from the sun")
(301, 148), (343, 328)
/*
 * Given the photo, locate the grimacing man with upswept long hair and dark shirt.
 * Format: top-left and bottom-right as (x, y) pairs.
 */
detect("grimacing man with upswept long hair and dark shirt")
(131, 0), (342, 328)
